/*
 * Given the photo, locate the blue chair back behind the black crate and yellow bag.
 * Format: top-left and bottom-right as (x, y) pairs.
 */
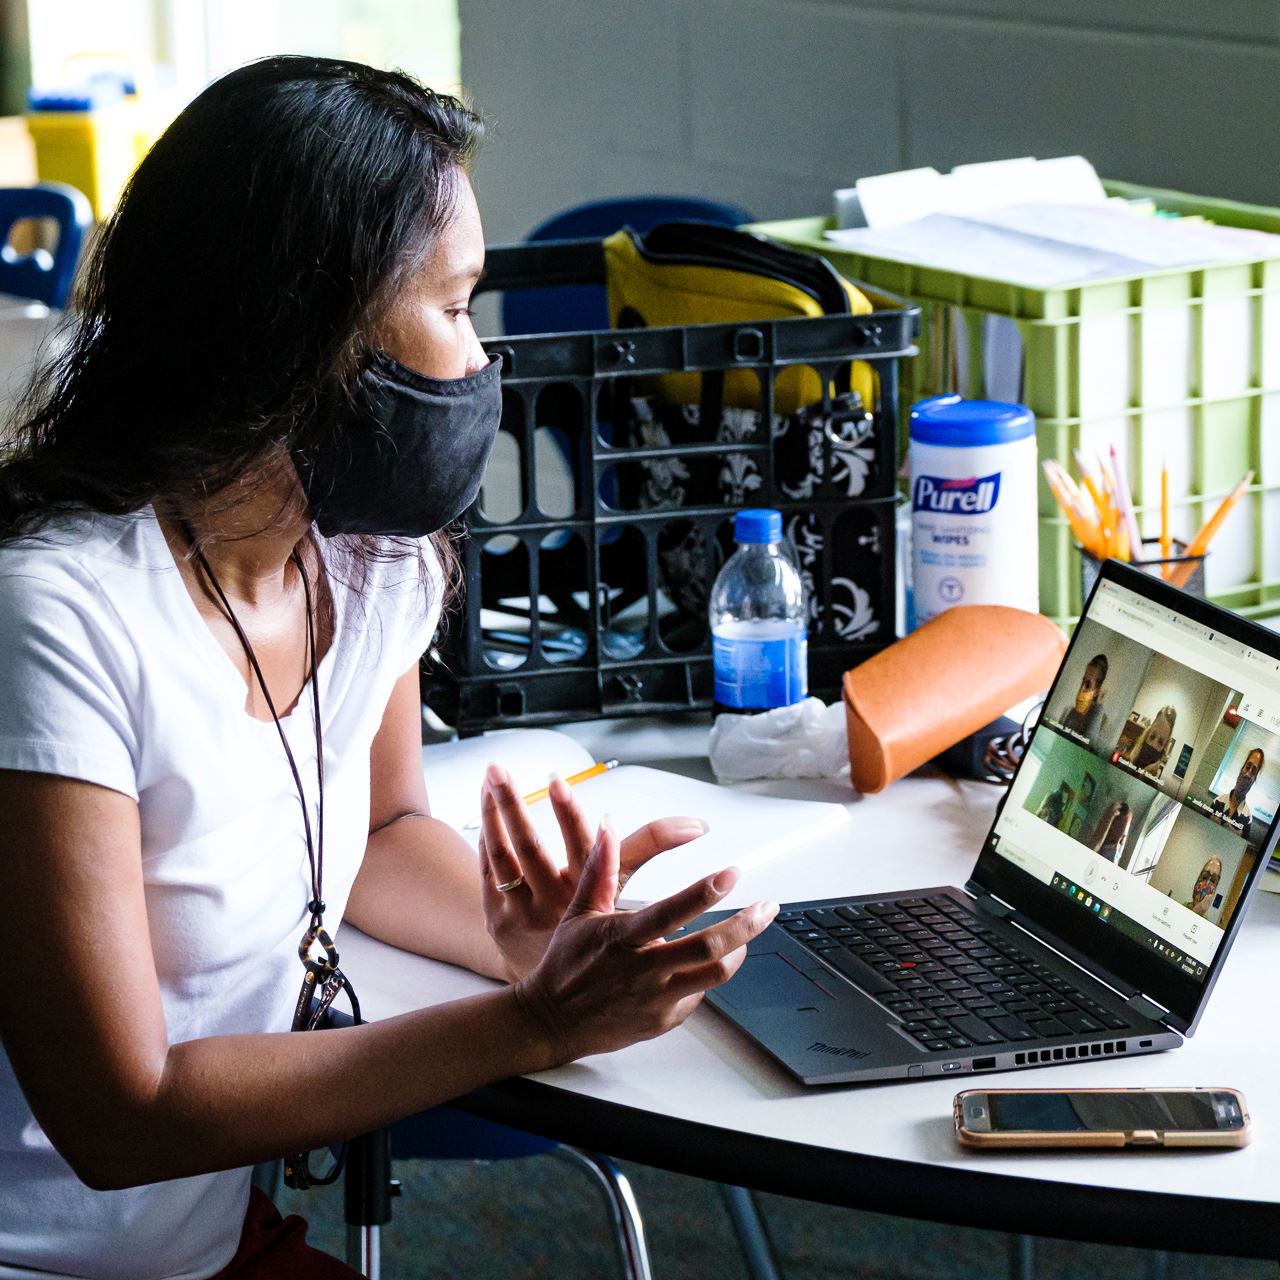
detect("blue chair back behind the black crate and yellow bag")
(502, 196), (753, 335)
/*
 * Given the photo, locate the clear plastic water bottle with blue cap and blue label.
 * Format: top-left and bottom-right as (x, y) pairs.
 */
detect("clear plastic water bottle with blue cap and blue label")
(710, 508), (809, 713)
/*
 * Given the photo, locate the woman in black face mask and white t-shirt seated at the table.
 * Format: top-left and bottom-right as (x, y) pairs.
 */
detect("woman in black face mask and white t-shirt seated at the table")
(0, 58), (776, 1280)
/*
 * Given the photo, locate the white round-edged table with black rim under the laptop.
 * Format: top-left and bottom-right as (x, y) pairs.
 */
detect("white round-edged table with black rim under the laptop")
(342, 721), (1280, 1258)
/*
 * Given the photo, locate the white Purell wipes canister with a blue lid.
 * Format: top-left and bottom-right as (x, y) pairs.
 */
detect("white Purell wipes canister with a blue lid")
(909, 396), (1039, 626)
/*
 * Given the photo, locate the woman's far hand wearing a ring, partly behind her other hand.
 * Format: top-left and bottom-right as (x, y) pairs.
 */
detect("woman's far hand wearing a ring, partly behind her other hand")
(480, 764), (707, 980)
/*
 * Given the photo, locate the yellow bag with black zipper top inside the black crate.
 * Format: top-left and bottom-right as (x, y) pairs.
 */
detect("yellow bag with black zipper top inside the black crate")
(604, 221), (877, 416)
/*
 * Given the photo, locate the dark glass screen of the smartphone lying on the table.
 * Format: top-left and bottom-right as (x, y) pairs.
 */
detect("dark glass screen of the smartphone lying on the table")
(987, 1091), (1243, 1133)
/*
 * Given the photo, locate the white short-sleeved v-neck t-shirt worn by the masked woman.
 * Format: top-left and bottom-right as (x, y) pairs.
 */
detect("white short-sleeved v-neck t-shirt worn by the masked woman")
(0, 509), (440, 1280)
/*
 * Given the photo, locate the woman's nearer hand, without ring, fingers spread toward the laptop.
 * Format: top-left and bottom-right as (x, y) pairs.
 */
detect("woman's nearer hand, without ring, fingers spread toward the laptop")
(515, 820), (778, 1064)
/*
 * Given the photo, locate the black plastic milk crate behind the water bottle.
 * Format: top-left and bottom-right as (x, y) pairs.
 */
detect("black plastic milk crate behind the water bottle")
(424, 241), (918, 735)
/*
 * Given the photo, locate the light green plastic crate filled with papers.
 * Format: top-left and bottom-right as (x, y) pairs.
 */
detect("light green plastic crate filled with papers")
(753, 182), (1280, 623)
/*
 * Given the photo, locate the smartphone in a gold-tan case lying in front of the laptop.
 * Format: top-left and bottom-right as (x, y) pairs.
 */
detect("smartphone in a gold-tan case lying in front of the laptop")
(955, 1089), (1249, 1148)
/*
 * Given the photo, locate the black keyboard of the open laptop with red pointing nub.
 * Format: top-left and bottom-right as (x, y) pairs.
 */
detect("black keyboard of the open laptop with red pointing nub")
(774, 893), (1130, 1051)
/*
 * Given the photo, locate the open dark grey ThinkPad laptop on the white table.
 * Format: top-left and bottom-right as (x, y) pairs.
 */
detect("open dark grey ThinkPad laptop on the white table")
(691, 561), (1280, 1084)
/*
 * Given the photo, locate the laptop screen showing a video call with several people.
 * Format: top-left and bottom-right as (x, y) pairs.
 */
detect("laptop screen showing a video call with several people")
(975, 567), (1280, 1023)
